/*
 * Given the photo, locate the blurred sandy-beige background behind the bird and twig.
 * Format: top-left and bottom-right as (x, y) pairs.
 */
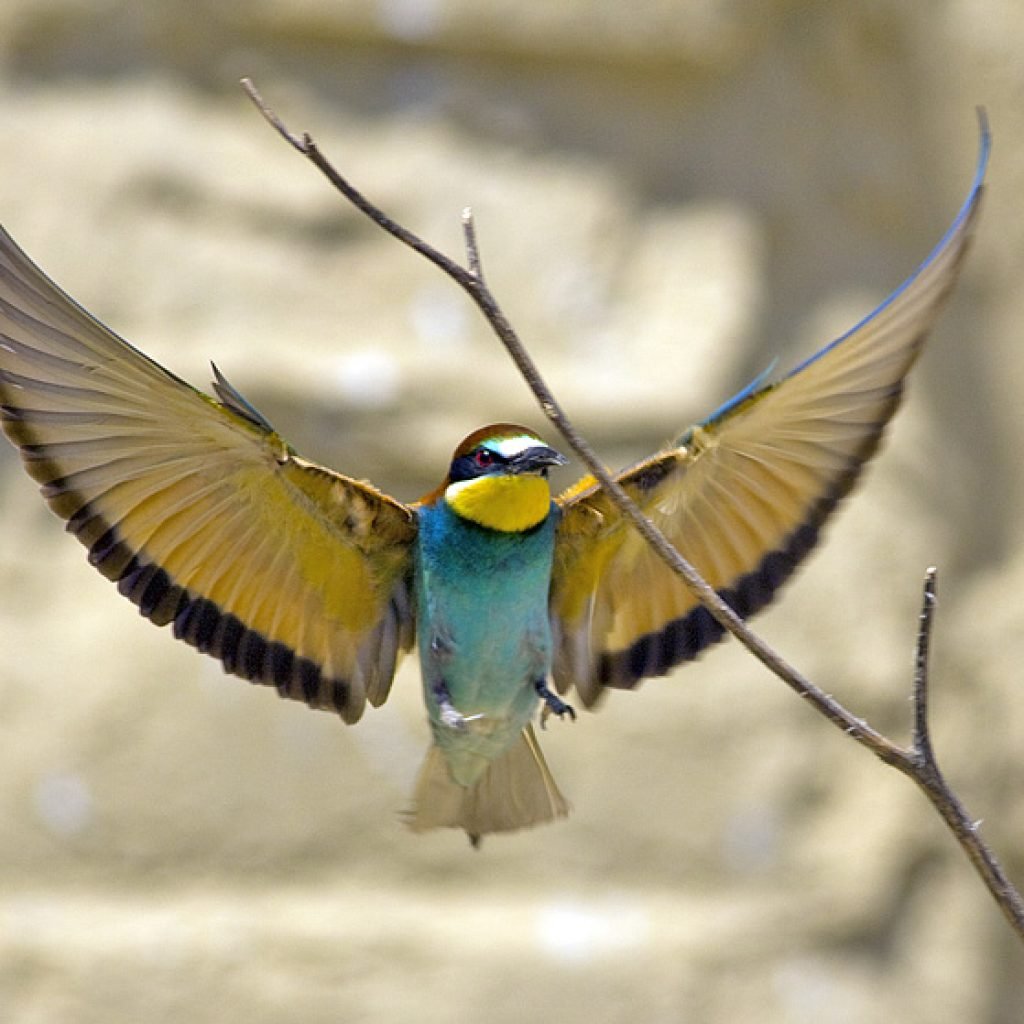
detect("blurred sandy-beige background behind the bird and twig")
(0, 0), (1024, 1024)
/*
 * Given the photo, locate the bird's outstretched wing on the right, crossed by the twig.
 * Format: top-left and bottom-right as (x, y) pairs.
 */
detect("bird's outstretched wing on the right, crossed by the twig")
(551, 125), (989, 705)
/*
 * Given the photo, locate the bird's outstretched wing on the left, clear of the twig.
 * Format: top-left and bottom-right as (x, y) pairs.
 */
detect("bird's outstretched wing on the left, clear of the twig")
(0, 228), (416, 722)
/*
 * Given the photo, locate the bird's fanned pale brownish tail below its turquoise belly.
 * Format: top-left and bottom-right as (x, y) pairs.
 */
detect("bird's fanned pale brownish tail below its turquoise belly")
(407, 725), (569, 846)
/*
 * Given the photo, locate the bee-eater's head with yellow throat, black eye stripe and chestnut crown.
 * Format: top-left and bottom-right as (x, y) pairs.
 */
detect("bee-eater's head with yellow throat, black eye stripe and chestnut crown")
(425, 423), (567, 534)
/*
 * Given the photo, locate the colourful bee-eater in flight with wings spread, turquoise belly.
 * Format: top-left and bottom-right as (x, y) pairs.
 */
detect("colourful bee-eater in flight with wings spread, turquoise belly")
(0, 122), (990, 845)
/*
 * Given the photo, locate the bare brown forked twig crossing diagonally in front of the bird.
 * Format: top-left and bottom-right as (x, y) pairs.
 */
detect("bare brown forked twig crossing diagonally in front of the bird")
(242, 79), (1024, 942)
